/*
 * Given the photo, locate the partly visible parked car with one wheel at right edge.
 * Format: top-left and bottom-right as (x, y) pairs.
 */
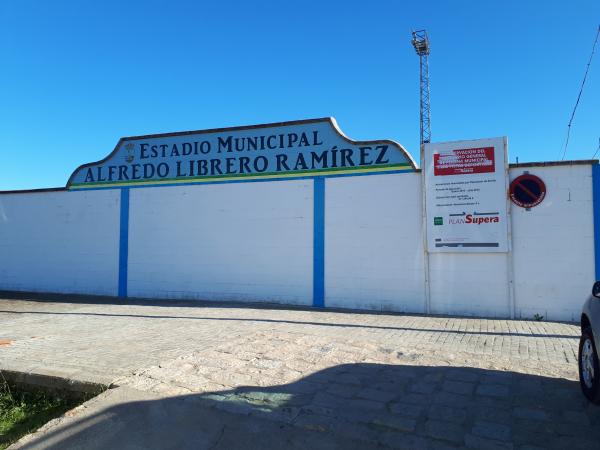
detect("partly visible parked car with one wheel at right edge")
(579, 281), (600, 404)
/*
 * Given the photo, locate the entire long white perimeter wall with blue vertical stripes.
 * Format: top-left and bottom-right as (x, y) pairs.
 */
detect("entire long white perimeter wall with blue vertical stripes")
(0, 162), (600, 321)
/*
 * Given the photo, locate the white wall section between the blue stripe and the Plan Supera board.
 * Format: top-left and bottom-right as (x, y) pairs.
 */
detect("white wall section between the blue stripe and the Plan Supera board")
(325, 173), (425, 312)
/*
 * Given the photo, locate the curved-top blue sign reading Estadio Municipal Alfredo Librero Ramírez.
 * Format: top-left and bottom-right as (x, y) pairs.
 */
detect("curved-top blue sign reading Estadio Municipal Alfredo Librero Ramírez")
(67, 118), (415, 189)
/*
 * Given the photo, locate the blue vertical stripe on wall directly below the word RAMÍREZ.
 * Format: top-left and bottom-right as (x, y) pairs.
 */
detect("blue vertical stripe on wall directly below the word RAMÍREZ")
(313, 177), (325, 308)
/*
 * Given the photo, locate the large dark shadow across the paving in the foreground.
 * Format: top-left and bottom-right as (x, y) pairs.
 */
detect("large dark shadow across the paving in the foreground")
(11, 363), (600, 450)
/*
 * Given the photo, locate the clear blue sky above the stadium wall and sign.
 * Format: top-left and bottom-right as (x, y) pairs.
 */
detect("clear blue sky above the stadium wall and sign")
(0, 0), (600, 190)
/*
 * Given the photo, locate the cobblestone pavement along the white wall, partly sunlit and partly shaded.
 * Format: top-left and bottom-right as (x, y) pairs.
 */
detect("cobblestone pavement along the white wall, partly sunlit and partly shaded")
(0, 294), (600, 449)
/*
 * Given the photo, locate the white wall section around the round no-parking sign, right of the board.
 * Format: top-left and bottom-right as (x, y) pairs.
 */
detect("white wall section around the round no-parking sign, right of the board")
(510, 165), (600, 320)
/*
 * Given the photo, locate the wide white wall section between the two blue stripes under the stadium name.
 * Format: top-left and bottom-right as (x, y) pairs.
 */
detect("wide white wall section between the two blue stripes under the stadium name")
(128, 180), (313, 305)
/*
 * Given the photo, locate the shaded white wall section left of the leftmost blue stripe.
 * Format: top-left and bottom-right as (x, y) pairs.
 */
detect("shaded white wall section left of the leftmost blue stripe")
(0, 190), (120, 295)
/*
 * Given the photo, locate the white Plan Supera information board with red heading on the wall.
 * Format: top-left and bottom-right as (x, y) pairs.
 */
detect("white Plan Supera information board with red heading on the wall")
(422, 137), (508, 253)
